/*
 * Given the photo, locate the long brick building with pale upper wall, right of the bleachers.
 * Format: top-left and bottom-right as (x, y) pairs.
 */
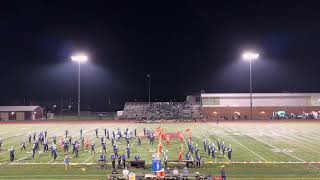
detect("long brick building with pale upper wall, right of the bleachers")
(200, 93), (320, 119)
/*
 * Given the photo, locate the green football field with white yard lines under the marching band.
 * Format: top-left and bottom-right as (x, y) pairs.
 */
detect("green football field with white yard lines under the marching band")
(0, 121), (320, 179)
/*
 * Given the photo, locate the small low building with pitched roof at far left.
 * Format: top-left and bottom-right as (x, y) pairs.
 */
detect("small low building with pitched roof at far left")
(0, 106), (43, 121)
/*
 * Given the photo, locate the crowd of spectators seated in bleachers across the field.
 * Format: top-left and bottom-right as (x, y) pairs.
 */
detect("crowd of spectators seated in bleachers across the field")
(123, 102), (201, 120)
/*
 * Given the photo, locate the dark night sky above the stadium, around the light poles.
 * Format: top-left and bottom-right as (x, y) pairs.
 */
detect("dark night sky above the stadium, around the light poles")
(0, 0), (320, 110)
